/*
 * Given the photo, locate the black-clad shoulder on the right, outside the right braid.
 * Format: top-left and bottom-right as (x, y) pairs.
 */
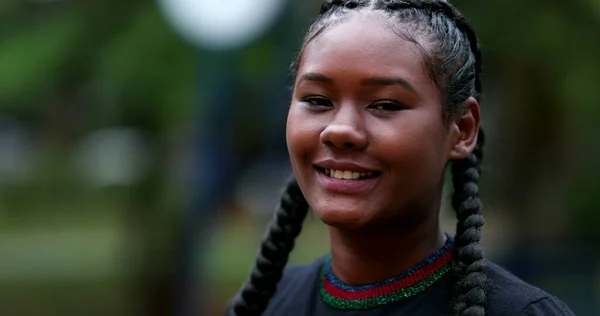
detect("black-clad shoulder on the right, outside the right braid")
(487, 261), (574, 316)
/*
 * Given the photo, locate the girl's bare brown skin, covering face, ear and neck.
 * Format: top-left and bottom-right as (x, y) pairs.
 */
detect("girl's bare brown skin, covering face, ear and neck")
(286, 11), (480, 285)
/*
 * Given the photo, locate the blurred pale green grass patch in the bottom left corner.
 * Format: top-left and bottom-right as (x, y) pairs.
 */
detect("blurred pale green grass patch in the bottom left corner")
(0, 203), (133, 316)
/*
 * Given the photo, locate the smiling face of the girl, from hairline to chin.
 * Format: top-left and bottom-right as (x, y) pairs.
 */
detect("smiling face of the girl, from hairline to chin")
(286, 12), (476, 229)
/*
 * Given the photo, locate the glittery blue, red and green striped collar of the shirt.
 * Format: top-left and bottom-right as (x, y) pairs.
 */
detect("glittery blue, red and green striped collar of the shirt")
(320, 236), (453, 310)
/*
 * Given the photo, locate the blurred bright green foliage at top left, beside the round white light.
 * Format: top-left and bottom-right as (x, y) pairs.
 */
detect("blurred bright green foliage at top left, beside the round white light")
(0, 4), (196, 127)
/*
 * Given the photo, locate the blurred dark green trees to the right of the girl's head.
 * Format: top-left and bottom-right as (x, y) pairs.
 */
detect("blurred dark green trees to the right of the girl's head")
(456, 0), (600, 242)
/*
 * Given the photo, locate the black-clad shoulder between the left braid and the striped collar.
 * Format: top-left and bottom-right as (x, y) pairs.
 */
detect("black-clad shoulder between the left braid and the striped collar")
(264, 257), (325, 315)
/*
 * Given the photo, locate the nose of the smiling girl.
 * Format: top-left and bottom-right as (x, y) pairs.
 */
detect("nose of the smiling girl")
(320, 109), (368, 150)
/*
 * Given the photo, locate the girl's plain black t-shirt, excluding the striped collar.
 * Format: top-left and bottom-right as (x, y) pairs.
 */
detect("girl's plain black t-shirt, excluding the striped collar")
(263, 258), (574, 316)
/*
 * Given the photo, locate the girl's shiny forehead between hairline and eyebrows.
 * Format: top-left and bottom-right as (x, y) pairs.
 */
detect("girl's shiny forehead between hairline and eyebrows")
(299, 11), (431, 84)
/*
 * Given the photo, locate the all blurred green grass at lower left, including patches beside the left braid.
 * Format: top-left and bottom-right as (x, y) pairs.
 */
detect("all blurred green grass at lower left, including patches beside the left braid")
(0, 200), (329, 316)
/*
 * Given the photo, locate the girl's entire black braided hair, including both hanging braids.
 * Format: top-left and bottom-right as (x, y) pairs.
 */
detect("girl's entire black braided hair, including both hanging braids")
(228, 0), (487, 316)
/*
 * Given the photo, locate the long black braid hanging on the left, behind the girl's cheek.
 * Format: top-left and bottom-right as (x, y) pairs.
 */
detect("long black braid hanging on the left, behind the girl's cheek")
(227, 177), (308, 316)
